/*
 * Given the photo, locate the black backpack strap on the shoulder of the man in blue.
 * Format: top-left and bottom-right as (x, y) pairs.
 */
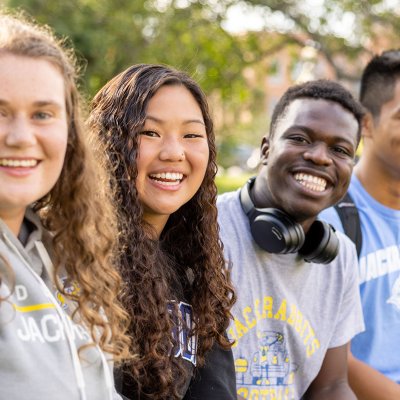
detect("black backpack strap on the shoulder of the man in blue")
(335, 192), (362, 257)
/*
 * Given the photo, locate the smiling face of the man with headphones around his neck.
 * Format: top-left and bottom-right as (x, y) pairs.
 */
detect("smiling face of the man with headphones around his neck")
(254, 98), (358, 222)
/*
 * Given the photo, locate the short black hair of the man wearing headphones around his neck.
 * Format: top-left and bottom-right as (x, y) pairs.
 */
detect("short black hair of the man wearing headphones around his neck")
(269, 79), (365, 142)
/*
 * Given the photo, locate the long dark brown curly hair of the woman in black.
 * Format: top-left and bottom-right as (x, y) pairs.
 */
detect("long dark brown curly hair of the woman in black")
(89, 64), (235, 399)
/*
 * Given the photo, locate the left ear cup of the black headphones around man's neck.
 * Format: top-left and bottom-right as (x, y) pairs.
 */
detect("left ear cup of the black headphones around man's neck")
(249, 208), (305, 253)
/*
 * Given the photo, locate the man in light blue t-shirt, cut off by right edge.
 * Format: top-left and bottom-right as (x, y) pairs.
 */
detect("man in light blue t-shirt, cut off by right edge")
(320, 50), (400, 400)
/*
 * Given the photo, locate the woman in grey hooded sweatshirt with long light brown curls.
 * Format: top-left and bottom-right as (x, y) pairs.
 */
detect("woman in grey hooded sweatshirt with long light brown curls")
(0, 11), (130, 400)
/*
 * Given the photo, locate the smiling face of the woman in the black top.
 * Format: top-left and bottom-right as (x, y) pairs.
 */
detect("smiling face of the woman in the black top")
(136, 85), (209, 235)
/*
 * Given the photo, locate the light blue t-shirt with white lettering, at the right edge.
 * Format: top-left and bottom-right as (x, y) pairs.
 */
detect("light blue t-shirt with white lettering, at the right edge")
(319, 174), (400, 383)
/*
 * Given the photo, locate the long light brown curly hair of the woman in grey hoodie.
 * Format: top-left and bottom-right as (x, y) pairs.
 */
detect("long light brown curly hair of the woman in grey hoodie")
(0, 11), (129, 360)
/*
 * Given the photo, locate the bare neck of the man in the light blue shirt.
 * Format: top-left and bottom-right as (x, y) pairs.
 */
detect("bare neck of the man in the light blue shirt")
(354, 152), (400, 210)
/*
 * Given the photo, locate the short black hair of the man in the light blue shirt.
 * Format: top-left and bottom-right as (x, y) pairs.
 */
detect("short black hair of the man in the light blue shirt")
(360, 49), (400, 121)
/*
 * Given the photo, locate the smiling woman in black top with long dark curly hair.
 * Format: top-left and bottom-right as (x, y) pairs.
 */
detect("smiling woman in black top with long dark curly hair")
(89, 64), (236, 400)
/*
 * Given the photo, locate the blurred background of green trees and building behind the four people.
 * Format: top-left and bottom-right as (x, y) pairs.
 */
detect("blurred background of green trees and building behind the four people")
(0, 0), (400, 192)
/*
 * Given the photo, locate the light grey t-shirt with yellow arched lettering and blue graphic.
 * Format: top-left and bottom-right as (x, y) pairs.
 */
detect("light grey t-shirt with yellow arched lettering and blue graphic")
(218, 191), (363, 400)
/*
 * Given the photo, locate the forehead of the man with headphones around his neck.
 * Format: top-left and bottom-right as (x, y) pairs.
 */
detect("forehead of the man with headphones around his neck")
(274, 98), (358, 144)
